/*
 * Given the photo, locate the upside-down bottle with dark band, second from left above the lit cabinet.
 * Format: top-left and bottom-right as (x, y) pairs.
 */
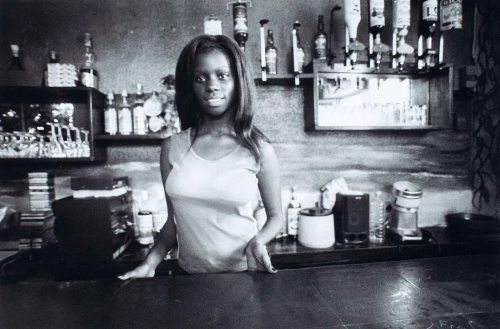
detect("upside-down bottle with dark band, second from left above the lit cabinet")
(368, 0), (390, 72)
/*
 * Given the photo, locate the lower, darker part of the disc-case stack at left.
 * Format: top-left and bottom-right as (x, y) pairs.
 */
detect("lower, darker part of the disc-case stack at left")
(19, 210), (56, 251)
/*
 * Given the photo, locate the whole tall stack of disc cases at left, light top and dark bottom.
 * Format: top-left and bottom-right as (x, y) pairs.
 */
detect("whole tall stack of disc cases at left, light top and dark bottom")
(19, 172), (55, 251)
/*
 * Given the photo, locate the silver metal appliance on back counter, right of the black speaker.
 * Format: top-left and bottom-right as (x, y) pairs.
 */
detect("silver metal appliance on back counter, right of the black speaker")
(389, 181), (423, 242)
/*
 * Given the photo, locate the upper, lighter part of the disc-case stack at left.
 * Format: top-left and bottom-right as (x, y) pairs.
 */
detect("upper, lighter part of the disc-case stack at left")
(28, 172), (56, 211)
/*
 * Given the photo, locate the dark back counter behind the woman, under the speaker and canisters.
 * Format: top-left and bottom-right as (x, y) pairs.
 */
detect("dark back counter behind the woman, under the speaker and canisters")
(0, 227), (500, 282)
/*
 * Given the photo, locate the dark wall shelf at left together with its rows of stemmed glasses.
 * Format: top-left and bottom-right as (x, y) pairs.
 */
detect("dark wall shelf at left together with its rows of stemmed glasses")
(0, 86), (106, 162)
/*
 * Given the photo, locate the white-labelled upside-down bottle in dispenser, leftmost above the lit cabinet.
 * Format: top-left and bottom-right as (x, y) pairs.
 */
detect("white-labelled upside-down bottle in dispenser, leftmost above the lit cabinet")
(344, 0), (366, 69)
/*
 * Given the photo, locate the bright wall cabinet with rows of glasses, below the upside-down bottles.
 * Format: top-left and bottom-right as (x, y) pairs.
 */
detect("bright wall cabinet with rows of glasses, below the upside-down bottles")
(306, 60), (453, 130)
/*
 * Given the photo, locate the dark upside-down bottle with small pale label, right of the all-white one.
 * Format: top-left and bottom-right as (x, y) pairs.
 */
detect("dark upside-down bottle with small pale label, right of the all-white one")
(417, 0), (438, 72)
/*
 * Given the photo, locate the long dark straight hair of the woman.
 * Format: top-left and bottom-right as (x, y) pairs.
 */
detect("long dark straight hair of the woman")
(175, 35), (268, 162)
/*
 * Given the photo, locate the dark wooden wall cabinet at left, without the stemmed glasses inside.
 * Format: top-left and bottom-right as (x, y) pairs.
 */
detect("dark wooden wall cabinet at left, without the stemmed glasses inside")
(0, 86), (106, 162)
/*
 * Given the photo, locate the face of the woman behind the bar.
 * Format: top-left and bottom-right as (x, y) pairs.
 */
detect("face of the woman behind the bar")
(193, 50), (235, 117)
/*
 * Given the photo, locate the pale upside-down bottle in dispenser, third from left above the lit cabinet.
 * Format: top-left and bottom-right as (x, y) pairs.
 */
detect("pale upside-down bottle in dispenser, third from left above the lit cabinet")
(392, 0), (415, 72)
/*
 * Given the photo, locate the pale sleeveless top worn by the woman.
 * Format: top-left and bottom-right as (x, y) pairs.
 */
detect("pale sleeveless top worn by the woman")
(165, 129), (260, 274)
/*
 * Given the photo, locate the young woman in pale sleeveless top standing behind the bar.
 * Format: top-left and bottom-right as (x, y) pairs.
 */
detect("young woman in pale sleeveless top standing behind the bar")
(119, 35), (283, 280)
